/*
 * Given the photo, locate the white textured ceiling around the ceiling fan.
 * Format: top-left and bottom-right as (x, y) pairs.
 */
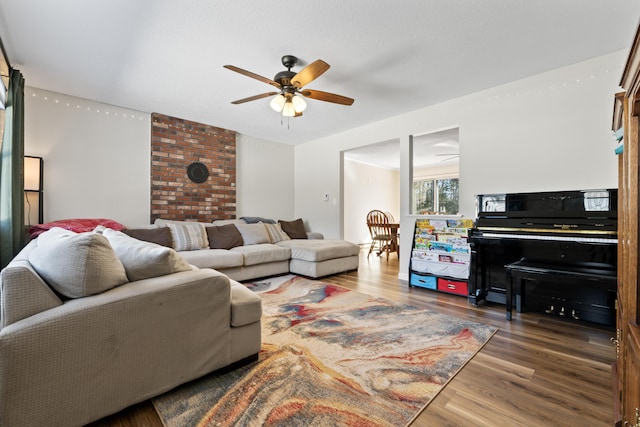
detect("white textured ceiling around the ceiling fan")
(0, 0), (640, 144)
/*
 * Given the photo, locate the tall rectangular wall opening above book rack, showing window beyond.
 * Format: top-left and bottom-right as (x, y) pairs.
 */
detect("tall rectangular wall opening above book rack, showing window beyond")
(411, 127), (460, 215)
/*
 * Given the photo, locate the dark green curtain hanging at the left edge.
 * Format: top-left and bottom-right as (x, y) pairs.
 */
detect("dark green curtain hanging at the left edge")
(0, 69), (25, 268)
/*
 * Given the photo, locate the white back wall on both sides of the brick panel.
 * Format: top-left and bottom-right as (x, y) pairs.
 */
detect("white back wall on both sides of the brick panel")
(25, 87), (294, 226)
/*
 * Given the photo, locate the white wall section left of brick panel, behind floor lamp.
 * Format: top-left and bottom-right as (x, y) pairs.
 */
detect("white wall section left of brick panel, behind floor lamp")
(25, 87), (151, 225)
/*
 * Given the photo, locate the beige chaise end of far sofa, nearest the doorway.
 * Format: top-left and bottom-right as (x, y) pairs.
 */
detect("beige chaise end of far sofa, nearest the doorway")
(276, 239), (360, 278)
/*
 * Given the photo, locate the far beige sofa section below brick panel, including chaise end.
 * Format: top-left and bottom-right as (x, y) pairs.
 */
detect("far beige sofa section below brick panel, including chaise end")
(149, 219), (360, 281)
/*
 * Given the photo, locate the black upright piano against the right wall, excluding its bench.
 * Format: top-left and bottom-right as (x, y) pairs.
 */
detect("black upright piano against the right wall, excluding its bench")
(469, 189), (618, 325)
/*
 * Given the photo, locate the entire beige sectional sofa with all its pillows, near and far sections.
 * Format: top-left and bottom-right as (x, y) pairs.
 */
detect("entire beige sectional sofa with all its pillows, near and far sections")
(0, 220), (359, 427)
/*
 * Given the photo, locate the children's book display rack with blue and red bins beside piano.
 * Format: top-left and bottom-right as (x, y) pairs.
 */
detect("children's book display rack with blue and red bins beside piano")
(409, 219), (473, 297)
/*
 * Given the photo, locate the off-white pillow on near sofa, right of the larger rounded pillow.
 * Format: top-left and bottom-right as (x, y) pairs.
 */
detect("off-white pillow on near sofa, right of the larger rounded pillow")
(102, 228), (191, 282)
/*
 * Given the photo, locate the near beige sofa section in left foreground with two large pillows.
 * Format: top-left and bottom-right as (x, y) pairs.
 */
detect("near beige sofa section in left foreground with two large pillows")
(0, 228), (262, 427)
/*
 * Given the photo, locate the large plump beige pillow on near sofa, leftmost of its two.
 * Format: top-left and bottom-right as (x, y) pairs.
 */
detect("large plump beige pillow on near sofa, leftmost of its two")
(29, 227), (128, 298)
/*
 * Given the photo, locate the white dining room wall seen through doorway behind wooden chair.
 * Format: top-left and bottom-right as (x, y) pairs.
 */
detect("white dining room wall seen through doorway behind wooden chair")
(344, 159), (400, 244)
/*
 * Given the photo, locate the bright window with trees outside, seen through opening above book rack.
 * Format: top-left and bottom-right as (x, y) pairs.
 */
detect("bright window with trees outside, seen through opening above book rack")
(413, 178), (460, 215)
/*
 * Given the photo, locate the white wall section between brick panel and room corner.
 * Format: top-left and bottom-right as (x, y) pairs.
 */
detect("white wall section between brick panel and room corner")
(236, 135), (294, 220)
